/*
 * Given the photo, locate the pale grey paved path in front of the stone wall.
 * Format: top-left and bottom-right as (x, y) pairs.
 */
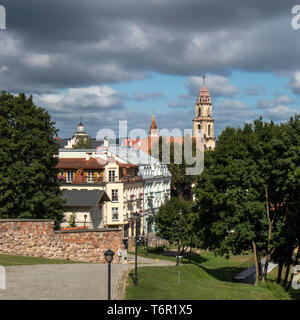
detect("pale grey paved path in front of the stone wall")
(0, 255), (174, 300)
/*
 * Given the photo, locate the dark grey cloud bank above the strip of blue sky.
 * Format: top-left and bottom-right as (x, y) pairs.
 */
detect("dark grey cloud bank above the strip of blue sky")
(0, 0), (300, 91)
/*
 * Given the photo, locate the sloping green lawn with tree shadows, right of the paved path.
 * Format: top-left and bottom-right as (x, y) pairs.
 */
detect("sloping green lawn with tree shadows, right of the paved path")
(126, 252), (286, 300)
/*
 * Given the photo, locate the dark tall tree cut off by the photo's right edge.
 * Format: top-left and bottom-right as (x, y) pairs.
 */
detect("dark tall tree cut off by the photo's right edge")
(271, 116), (300, 288)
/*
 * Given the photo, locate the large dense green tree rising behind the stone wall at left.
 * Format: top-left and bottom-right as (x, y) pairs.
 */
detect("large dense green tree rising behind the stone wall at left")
(0, 91), (63, 227)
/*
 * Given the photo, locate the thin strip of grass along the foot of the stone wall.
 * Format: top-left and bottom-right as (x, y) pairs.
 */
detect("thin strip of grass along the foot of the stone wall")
(0, 254), (80, 266)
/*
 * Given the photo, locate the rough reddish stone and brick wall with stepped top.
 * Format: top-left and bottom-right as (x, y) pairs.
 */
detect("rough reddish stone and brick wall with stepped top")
(0, 219), (123, 263)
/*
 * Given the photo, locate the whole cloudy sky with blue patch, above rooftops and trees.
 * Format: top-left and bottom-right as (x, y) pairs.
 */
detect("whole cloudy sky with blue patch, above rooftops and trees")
(0, 0), (300, 138)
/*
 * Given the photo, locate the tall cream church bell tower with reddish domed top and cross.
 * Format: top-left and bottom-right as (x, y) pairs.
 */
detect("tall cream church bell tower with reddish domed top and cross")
(193, 76), (216, 149)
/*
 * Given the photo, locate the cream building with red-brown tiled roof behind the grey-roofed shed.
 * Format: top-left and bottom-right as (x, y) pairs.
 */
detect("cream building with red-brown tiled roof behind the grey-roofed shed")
(57, 149), (144, 238)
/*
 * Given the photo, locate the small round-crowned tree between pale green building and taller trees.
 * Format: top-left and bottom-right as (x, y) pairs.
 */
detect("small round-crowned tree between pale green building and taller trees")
(154, 198), (197, 254)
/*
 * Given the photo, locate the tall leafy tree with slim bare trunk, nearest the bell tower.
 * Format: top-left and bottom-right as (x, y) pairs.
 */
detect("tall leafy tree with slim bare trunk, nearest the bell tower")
(195, 125), (266, 283)
